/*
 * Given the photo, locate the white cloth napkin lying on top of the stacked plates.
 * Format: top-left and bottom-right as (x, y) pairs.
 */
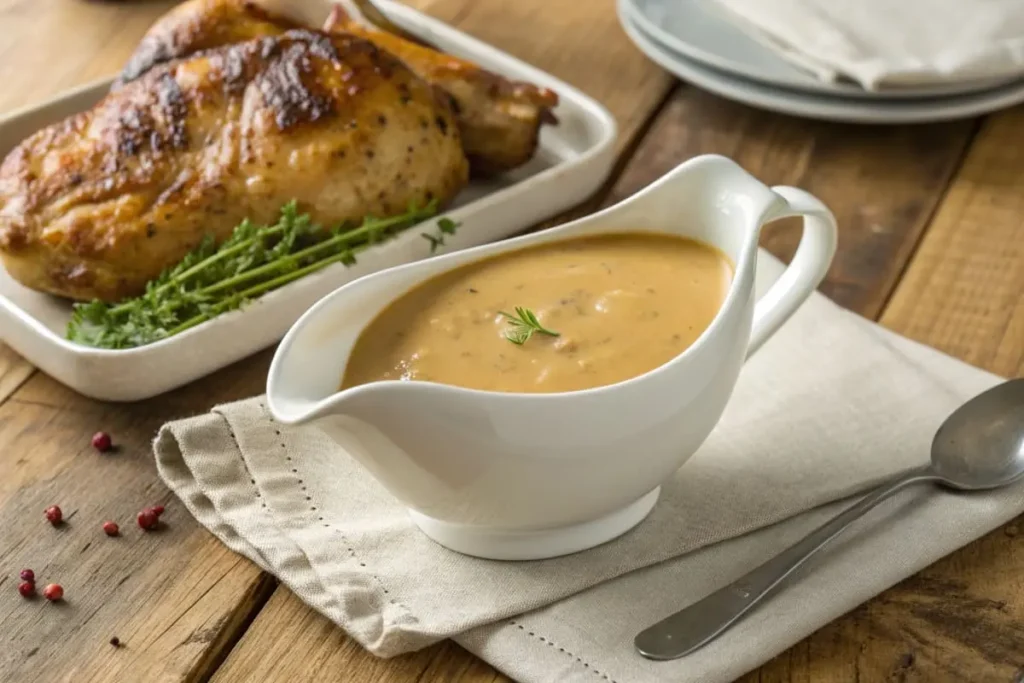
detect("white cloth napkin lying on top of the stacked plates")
(714, 0), (1024, 89)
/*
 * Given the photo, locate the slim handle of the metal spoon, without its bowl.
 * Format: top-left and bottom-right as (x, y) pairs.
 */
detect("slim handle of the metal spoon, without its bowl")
(633, 466), (938, 659)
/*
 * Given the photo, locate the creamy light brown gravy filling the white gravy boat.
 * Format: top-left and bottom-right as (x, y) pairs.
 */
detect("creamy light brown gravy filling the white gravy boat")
(342, 232), (732, 393)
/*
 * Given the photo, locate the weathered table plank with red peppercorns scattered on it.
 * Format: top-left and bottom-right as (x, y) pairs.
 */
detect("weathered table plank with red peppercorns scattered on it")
(0, 366), (272, 683)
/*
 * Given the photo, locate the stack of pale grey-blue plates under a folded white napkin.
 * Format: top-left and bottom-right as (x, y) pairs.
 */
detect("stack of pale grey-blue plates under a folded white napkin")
(618, 0), (1024, 123)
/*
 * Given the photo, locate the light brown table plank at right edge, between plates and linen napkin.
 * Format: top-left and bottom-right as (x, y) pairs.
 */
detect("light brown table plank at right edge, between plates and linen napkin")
(882, 108), (1024, 377)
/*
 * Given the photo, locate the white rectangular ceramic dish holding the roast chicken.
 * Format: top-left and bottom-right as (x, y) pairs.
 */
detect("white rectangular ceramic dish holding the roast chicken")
(0, 0), (616, 401)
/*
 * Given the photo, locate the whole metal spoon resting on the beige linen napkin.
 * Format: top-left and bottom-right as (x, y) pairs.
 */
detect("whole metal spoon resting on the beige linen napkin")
(633, 379), (1024, 659)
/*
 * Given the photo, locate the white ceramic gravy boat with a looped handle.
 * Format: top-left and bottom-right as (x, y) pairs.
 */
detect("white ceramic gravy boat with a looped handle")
(267, 156), (837, 559)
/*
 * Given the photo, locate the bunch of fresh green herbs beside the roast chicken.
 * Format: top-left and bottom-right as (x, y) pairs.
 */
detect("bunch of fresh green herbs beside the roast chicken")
(67, 197), (437, 349)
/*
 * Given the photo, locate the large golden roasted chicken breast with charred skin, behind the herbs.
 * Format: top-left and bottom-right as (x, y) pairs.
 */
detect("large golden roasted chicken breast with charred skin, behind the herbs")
(0, 30), (468, 302)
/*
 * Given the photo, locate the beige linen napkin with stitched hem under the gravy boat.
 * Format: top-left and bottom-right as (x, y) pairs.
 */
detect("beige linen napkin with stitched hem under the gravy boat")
(156, 253), (1024, 683)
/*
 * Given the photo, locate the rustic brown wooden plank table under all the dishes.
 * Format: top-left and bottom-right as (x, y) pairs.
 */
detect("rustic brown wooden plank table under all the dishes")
(0, 0), (1024, 683)
